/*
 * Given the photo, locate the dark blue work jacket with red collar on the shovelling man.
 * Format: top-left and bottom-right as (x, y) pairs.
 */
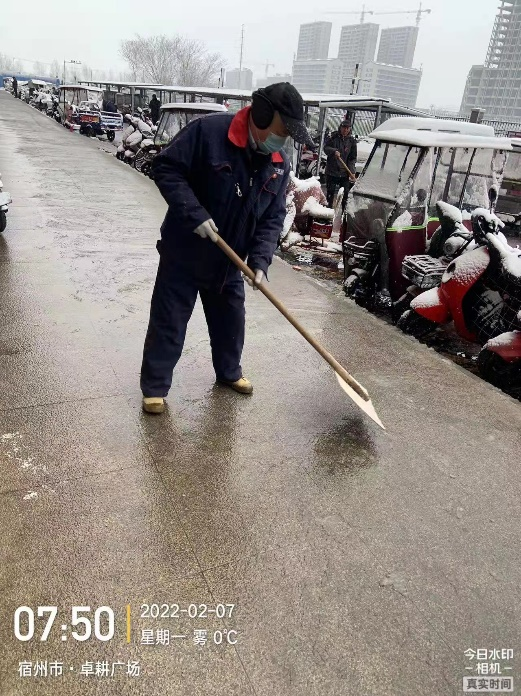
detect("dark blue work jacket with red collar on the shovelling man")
(153, 107), (290, 285)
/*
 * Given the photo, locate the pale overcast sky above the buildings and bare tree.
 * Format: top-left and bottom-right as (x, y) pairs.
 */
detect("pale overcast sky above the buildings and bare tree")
(0, 0), (498, 108)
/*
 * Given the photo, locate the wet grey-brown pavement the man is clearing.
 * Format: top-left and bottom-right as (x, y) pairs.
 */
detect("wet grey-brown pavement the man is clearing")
(0, 92), (521, 696)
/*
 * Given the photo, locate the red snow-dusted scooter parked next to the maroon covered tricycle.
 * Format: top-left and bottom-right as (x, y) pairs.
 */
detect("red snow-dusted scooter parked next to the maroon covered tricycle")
(398, 208), (521, 354)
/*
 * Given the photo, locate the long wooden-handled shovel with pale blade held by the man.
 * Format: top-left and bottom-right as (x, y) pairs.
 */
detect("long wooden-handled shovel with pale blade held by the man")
(209, 235), (385, 430)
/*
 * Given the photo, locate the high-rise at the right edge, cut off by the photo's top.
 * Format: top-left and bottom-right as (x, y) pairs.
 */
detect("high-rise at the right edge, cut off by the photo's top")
(461, 0), (521, 122)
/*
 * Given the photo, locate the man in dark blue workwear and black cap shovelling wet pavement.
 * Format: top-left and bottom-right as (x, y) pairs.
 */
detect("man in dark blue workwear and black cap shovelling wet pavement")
(141, 82), (313, 413)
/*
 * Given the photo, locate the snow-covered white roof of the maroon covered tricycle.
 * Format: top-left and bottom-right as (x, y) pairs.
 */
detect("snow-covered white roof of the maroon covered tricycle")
(371, 128), (512, 151)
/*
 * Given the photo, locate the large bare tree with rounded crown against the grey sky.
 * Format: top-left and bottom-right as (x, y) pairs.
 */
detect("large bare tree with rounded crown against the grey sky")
(120, 35), (222, 87)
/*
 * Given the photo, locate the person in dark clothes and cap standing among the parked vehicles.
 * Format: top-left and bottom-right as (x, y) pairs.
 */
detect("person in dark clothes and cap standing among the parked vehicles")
(324, 121), (356, 209)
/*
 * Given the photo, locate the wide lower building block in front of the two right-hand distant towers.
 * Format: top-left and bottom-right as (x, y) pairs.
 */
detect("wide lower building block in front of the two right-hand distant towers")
(358, 62), (422, 107)
